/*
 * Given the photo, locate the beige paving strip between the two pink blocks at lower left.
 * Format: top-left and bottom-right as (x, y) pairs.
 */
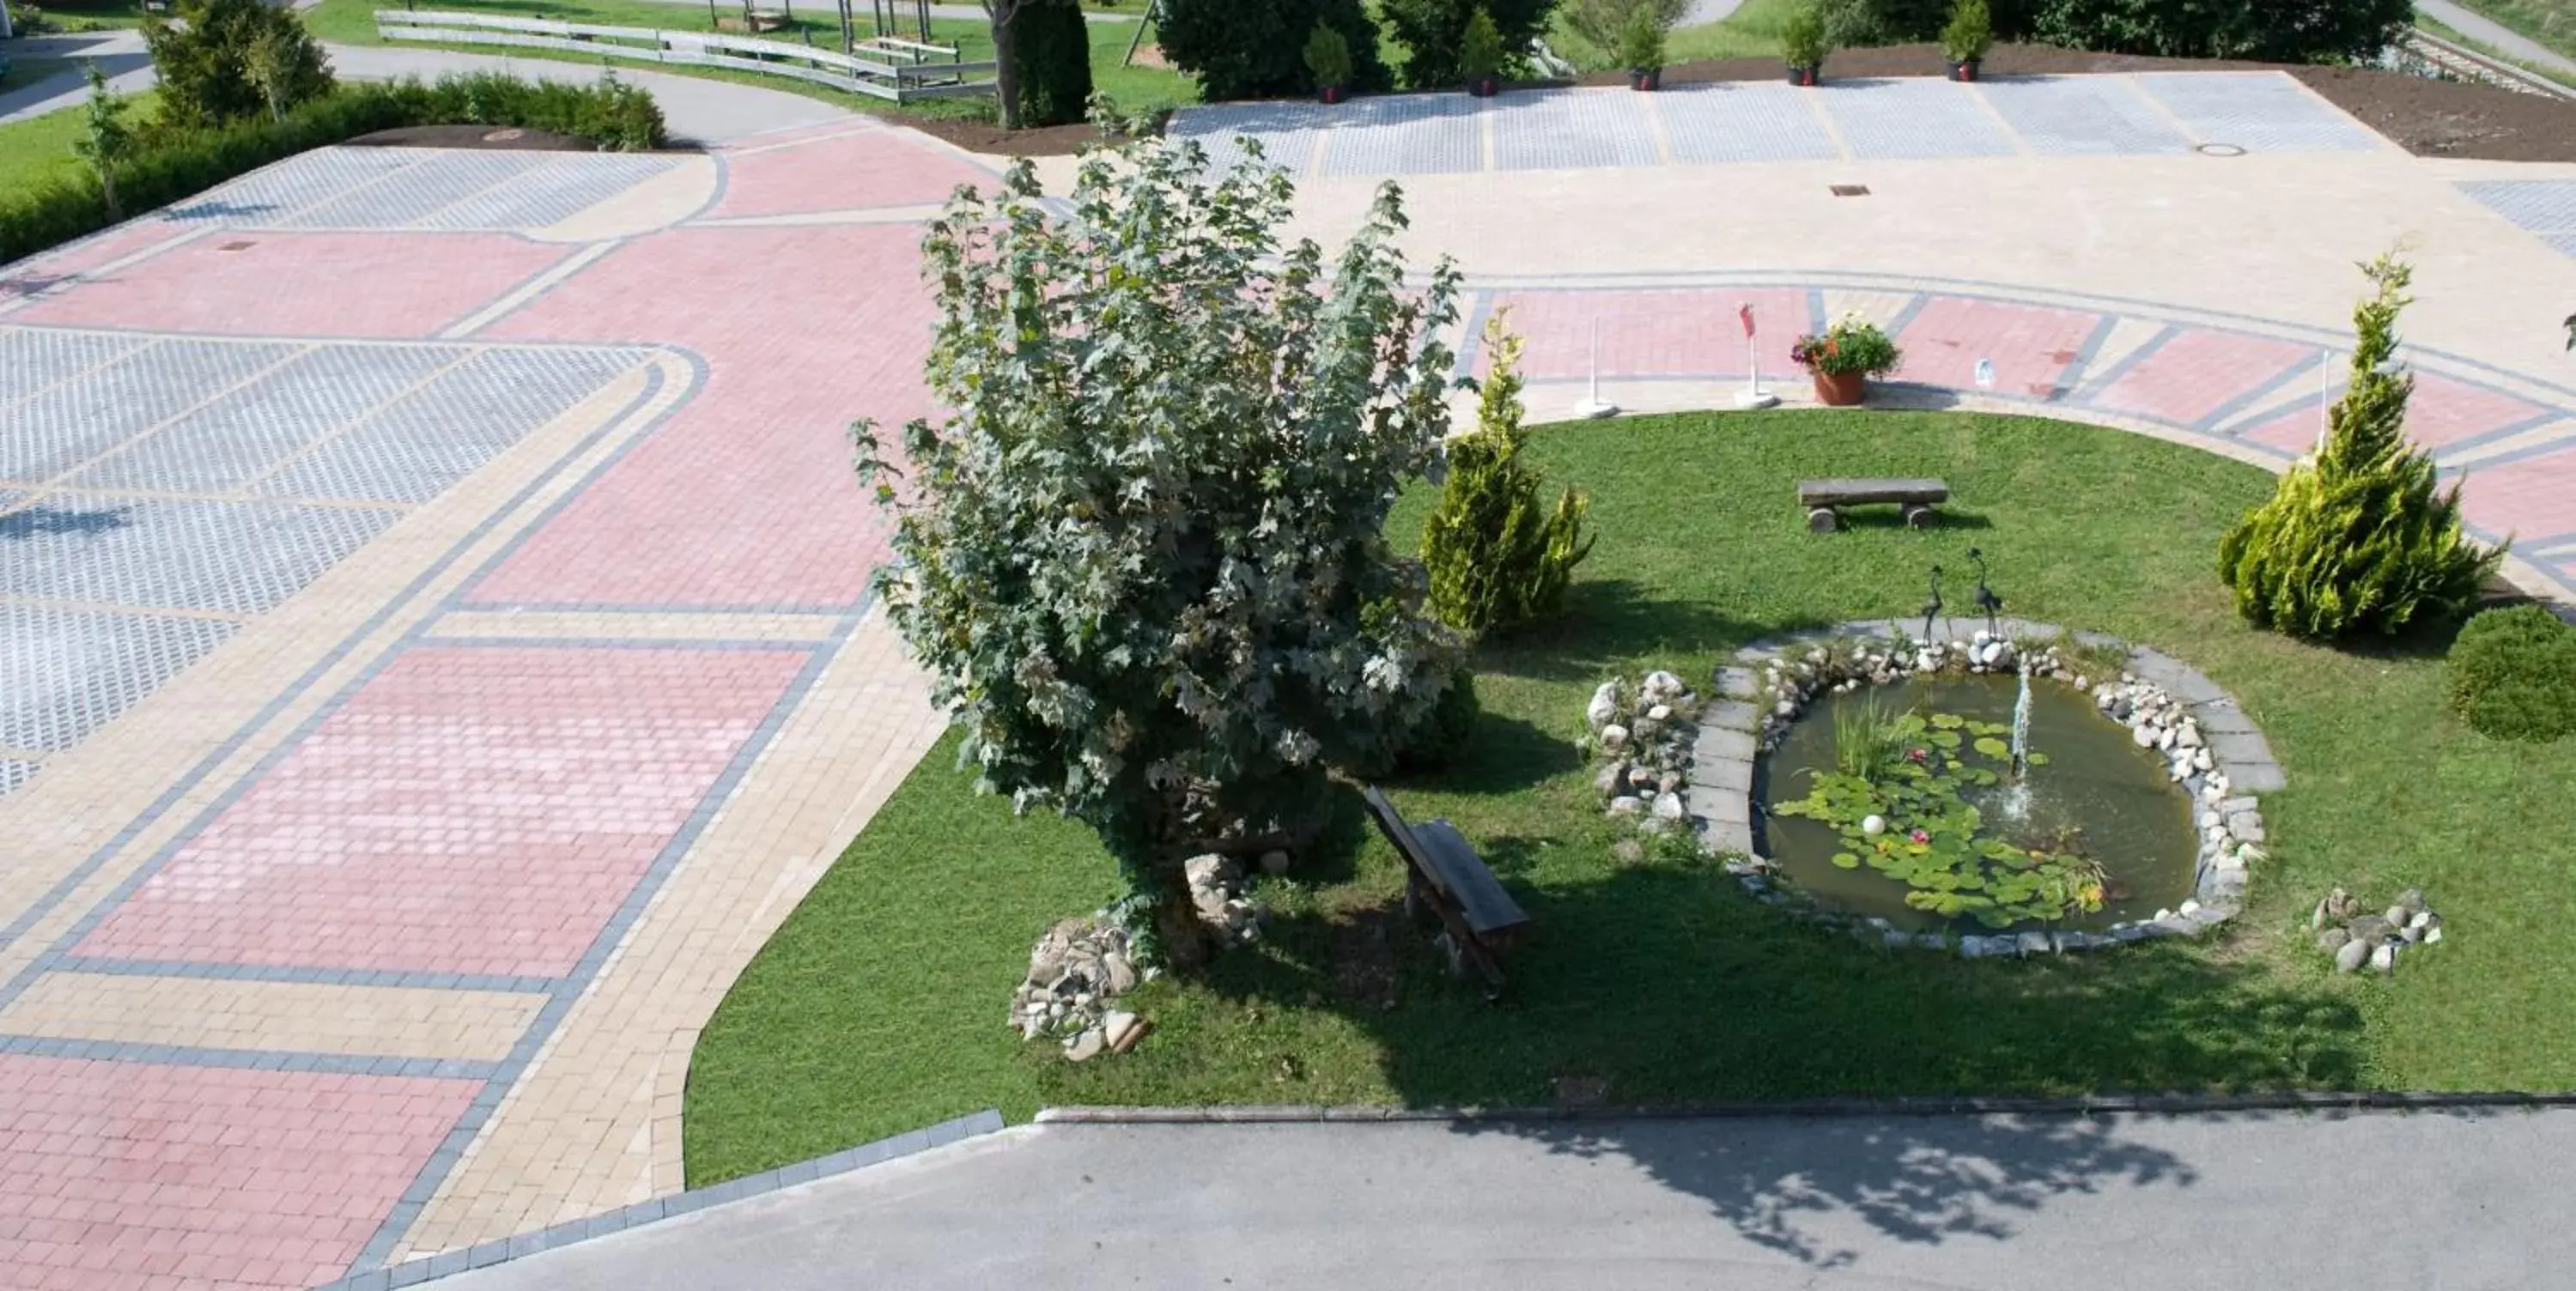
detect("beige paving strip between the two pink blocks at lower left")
(0, 972), (546, 1062)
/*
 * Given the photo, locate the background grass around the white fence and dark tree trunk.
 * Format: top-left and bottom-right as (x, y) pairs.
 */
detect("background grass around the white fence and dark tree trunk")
(304, 0), (1198, 116)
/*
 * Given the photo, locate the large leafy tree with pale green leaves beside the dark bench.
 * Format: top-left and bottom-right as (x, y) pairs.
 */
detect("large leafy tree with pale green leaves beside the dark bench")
(855, 139), (1458, 964)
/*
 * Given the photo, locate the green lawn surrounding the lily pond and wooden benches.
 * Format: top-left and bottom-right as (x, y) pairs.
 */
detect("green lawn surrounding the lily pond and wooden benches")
(685, 412), (2576, 1183)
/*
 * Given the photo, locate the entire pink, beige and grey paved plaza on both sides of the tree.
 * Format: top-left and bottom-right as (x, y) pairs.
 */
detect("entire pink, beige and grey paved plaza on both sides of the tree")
(0, 75), (2576, 1291)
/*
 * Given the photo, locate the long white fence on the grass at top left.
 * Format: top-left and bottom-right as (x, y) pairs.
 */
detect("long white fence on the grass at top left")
(376, 10), (994, 103)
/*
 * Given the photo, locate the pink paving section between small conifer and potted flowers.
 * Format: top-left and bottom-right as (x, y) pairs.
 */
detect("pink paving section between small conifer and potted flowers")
(1476, 286), (1808, 381)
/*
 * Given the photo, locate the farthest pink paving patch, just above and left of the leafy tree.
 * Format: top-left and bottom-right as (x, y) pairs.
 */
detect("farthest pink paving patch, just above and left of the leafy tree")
(708, 129), (994, 219)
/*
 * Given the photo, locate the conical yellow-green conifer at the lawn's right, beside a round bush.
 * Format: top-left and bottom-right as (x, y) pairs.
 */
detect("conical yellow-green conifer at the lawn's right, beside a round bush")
(2218, 255), (2504, 641)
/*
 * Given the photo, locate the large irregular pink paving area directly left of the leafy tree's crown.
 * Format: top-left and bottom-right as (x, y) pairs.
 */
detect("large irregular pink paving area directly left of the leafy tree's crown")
(471, 224), (933, 605)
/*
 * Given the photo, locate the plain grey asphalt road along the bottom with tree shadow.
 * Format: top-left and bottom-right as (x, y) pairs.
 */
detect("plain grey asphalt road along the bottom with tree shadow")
(435, 1111), (2576, 1291)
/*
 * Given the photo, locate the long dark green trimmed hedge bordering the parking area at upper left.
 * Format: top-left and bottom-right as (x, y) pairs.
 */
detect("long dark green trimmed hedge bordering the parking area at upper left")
(0, 75), (667, 265)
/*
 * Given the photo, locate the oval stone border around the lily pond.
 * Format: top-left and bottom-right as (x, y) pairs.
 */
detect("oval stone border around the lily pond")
(1682, 618), (2287, 959)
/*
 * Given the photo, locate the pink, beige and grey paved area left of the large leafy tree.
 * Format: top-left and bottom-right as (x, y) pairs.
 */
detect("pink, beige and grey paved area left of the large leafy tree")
(0, 121), (989, 1288)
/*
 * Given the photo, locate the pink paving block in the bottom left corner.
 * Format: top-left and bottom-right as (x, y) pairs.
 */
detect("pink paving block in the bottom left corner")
(0, 1054), (482, 1291)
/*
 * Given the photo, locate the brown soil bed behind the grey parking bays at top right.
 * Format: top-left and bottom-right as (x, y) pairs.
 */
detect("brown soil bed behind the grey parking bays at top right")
(1582, 44), (2576, 162)
